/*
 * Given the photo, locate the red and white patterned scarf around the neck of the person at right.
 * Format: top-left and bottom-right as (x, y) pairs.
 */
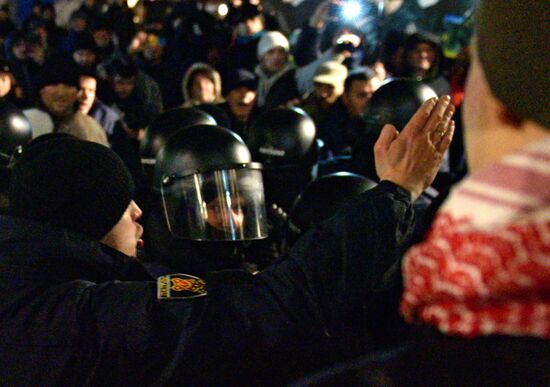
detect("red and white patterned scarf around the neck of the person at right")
(401, 138), (550, 338)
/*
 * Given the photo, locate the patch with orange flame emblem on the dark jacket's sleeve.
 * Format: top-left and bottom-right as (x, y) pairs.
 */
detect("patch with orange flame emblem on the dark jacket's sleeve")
(157, 273), (207, 300)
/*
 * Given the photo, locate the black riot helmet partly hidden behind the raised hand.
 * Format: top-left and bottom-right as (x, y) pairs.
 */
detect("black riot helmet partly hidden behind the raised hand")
(352, 79), (437, 180)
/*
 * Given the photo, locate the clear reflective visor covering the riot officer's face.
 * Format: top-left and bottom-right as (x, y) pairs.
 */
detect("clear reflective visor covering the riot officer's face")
(161, 168), (267, 241)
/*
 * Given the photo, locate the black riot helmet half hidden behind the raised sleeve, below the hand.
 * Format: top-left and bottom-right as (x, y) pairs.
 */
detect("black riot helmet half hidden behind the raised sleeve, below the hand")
(285, 172), (376, 247)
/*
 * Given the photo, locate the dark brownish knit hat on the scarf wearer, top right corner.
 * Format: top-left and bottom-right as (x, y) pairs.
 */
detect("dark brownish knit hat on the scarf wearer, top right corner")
(476, 0), (550, 128)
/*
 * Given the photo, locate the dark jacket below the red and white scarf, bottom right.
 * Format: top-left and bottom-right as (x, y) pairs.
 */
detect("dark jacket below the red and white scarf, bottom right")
(295, 331), (550, 387)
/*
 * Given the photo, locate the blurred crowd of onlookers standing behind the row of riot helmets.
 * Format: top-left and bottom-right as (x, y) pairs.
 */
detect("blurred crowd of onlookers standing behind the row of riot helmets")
(0, 0), (463, 155)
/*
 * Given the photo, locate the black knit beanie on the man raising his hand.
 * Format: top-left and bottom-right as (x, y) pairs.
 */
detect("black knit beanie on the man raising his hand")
(9, 136), (134, 240)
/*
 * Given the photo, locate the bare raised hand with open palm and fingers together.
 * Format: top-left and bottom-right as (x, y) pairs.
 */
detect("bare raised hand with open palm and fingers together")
(374, 96), (455, 199)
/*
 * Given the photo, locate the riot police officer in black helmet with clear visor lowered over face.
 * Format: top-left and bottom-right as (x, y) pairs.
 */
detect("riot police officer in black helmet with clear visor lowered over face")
(145, 125), (267, 276)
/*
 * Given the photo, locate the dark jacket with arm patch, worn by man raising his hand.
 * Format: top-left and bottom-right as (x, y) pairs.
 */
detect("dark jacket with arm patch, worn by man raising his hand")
(0, 182), (412, 386)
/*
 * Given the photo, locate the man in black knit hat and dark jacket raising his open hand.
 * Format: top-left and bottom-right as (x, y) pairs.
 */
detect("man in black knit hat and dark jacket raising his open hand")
(0, 84), (453, 386)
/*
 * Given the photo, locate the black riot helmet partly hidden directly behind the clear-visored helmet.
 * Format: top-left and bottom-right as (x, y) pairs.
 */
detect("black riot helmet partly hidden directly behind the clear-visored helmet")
(139, 107), (217, 165)
